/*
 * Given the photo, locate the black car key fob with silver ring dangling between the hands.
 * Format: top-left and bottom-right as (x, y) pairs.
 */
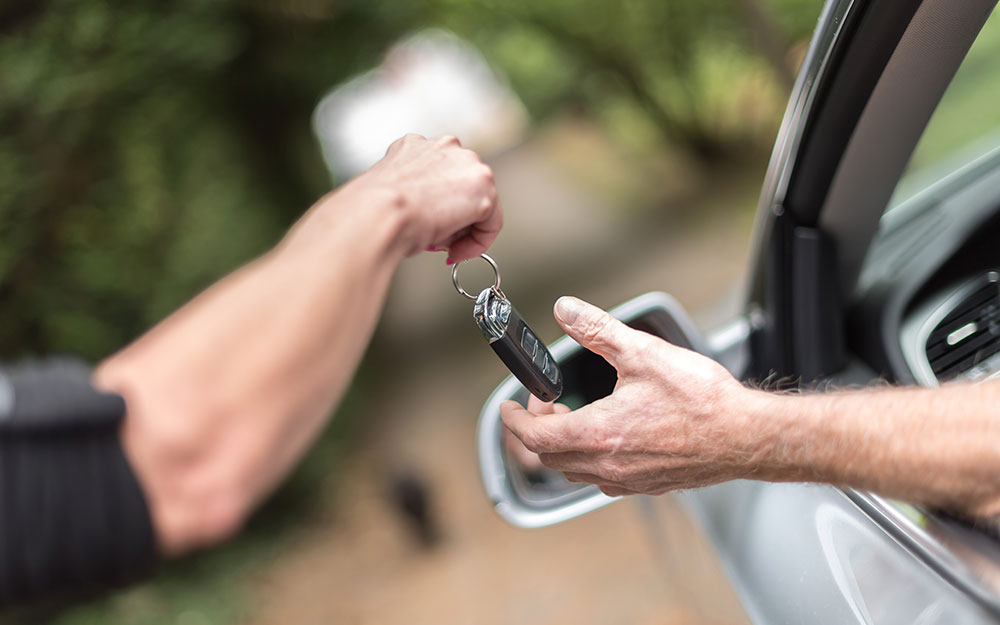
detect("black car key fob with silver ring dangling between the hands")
(451, 254), (563, 401)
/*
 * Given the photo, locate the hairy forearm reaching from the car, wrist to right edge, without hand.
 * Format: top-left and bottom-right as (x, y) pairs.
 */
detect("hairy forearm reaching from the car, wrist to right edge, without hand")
(754, 382), (1000, 516)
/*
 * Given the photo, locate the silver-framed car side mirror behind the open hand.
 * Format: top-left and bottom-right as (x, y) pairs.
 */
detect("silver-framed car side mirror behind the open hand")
(477, 292), (709, 527)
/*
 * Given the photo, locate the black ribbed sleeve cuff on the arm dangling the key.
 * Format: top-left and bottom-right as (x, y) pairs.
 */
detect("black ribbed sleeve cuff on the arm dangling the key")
(0, 359), (156, 608)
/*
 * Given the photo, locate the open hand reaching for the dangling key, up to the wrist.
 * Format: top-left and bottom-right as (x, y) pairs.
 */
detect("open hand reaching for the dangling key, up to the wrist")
(500, 297), (769, 496)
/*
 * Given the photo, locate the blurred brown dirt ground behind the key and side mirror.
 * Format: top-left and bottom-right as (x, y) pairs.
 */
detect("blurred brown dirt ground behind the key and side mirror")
(240, 128), (760, 625)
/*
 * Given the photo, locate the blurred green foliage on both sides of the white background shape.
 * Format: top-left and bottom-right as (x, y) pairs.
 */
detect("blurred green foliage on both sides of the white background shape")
(0, 0), (818, 359)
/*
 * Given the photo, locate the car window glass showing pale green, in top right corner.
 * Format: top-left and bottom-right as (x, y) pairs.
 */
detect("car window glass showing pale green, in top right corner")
(889, 3), (1000, 208)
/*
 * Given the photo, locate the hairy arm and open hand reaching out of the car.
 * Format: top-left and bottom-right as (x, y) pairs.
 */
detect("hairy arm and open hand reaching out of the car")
(501, 298), (1000, 516)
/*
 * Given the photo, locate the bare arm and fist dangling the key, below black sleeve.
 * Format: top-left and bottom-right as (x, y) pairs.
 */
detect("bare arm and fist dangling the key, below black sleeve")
(95, 136), (501, 554)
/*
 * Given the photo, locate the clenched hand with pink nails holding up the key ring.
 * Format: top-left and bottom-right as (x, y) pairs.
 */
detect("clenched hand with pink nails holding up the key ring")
(349, 134), (503, 263)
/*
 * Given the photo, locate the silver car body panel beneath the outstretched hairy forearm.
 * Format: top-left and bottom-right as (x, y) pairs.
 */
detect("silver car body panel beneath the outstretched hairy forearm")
(680, 481), (996, 625)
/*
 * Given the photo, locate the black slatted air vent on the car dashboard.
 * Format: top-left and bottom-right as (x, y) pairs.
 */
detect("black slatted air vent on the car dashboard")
(925, 271), (1000, 382)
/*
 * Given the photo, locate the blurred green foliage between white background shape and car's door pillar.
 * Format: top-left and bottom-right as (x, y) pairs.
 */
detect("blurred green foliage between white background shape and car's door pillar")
(438, 0), (819, 156)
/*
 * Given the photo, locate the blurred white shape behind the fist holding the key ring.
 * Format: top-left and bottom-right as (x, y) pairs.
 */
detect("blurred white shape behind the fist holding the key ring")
(313, 29), (528, 180)
